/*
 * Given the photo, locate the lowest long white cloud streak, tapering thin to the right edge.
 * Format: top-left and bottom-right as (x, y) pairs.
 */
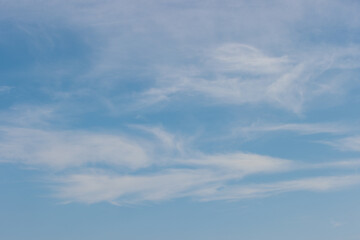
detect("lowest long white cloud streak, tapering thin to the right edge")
(54, 169), (360, 205)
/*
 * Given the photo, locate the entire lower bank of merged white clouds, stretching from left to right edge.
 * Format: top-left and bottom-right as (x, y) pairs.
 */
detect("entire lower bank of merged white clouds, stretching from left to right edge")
(0, 122), (360, 205)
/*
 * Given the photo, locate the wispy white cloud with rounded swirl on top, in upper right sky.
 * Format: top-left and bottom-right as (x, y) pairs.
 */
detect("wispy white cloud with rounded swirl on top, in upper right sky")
(142, 43), (360, 113)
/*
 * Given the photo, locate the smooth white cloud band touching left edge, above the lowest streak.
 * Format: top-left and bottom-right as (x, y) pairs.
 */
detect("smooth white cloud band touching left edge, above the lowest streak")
(0, 127), (149, 170)
